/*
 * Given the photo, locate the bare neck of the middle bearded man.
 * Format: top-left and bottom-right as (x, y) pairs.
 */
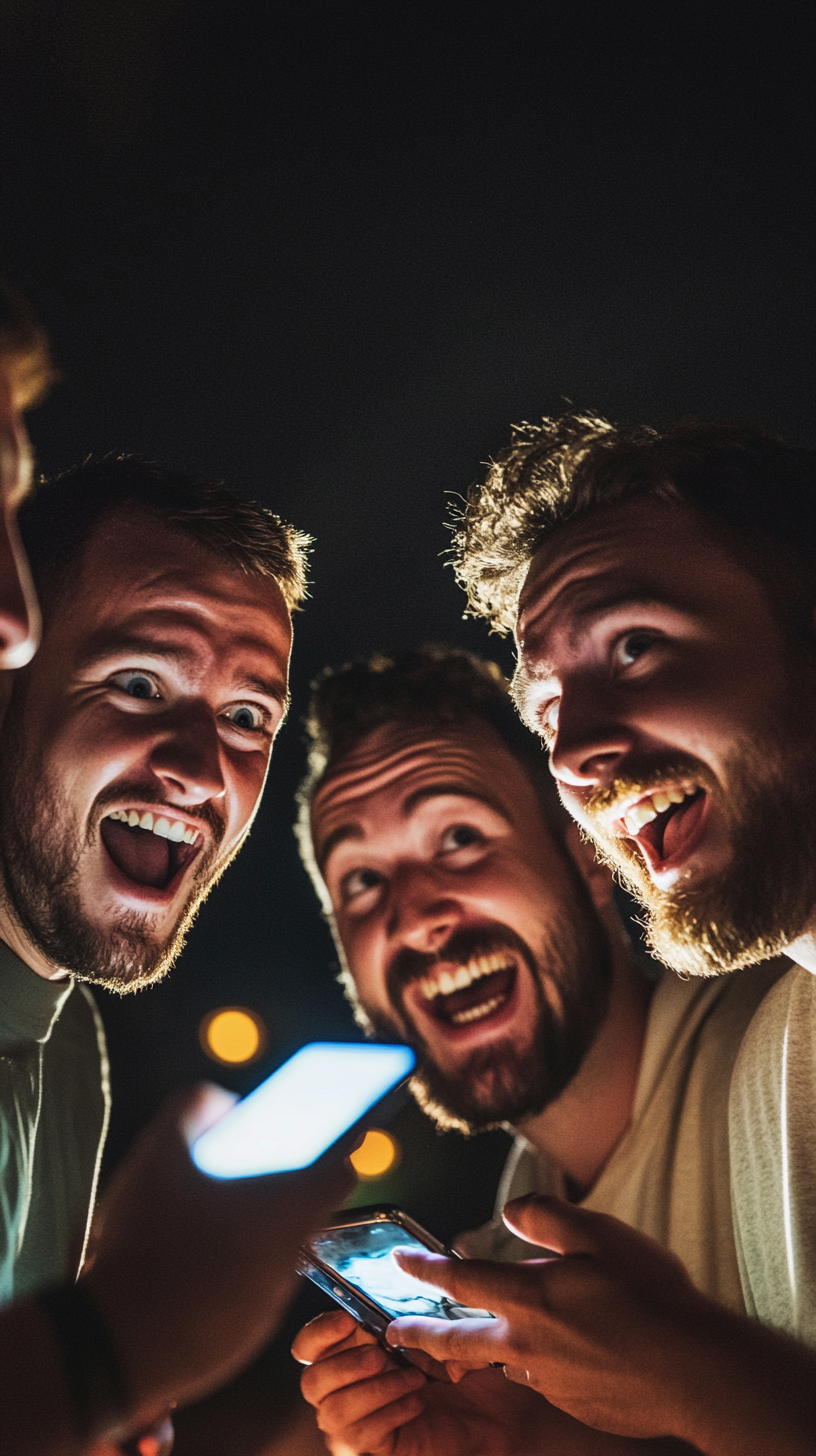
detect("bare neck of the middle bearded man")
(517, 907), (653, 1197)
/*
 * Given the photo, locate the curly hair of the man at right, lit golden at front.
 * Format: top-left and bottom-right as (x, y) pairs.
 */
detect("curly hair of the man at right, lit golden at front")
(455, 414), (816, 632)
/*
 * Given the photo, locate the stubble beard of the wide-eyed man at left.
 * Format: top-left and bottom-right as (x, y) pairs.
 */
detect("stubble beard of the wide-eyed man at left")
(0, 718), (233, 994)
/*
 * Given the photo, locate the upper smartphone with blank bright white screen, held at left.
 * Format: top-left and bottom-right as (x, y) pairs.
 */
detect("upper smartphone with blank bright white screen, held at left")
(191, 1041), (417, 1178)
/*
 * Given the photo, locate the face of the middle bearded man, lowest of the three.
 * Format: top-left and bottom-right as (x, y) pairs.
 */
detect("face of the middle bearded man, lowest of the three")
(312, 722), (611, 1125)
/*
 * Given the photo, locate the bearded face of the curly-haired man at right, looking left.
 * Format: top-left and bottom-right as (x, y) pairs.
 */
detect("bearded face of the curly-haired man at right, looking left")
(516, 496), (816, 974)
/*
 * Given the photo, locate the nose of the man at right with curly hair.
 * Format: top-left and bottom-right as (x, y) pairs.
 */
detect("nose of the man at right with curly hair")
(549, 684), (635, 789)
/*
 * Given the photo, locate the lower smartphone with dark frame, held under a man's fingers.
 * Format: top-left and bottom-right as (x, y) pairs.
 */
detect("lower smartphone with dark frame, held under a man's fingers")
(299, 1204), (495, 1354)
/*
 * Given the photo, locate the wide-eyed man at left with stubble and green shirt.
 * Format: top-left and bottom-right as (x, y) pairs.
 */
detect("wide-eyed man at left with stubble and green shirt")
(0, 459), (303, 1300)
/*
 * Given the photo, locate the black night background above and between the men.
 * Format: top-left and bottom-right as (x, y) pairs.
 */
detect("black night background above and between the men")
(0, 0), (816, 1452)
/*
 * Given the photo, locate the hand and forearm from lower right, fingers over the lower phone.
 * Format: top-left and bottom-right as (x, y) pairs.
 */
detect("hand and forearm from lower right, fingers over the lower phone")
(388, 1198), (816, 1456)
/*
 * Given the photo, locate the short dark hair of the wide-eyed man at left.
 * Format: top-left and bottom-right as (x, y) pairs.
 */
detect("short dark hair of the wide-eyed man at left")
(19, 454), (310, 612)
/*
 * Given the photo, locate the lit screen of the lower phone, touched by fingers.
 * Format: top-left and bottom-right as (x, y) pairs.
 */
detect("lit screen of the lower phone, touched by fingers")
(310, 1223), (494, 1319)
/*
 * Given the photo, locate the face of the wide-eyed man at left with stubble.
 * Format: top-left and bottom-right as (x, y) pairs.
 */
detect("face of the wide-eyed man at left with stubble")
(0, 513), (291, 989)
